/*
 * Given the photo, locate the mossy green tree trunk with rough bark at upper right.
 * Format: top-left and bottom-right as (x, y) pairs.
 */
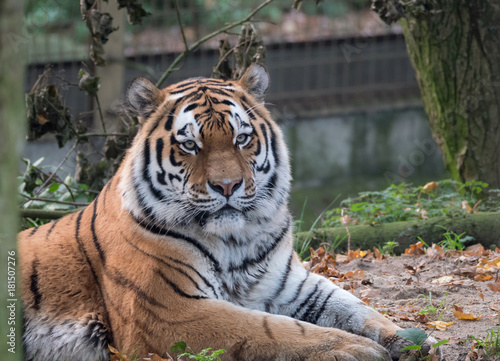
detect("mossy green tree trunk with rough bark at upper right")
(372, 0), (500, 188)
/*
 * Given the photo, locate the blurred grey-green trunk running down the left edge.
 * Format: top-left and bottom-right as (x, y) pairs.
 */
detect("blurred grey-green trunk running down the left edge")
(0, 0), (25, 361)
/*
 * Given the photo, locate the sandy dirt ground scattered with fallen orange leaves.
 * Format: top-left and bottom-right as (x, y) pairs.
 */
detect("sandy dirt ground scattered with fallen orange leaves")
(309, 245), (500, 361)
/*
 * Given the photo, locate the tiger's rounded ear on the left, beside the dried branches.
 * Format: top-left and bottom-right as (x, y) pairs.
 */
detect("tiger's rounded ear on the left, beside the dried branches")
(125, 78), (163, 124)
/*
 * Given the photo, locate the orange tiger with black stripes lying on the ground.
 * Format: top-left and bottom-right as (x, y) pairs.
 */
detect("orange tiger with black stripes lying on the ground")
(18, 64), (438, 361)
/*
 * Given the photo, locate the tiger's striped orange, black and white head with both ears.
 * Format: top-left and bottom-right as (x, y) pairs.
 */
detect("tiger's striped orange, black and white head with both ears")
(120, 65), (290, 236)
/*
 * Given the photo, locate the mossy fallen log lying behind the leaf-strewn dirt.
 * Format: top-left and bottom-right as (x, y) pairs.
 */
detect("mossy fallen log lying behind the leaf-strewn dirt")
(298, 212), (500, 253)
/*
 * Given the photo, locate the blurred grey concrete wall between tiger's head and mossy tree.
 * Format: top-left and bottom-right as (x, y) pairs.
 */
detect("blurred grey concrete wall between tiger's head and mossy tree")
(283, 107), (444, 188)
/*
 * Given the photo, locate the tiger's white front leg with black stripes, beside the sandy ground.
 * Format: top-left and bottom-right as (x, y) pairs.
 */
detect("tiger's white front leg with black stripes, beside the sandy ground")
(265, 256), (430, 360)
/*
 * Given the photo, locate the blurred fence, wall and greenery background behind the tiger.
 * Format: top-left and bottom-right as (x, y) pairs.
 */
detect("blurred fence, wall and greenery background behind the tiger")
(24, 0), (447, 226)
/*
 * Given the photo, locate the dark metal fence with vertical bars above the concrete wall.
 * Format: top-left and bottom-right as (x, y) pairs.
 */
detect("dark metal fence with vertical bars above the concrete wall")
(26, 34), (419, 117)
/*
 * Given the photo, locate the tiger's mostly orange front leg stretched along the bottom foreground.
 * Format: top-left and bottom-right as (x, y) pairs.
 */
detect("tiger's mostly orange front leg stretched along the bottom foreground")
(139, 299), (390, 361)
